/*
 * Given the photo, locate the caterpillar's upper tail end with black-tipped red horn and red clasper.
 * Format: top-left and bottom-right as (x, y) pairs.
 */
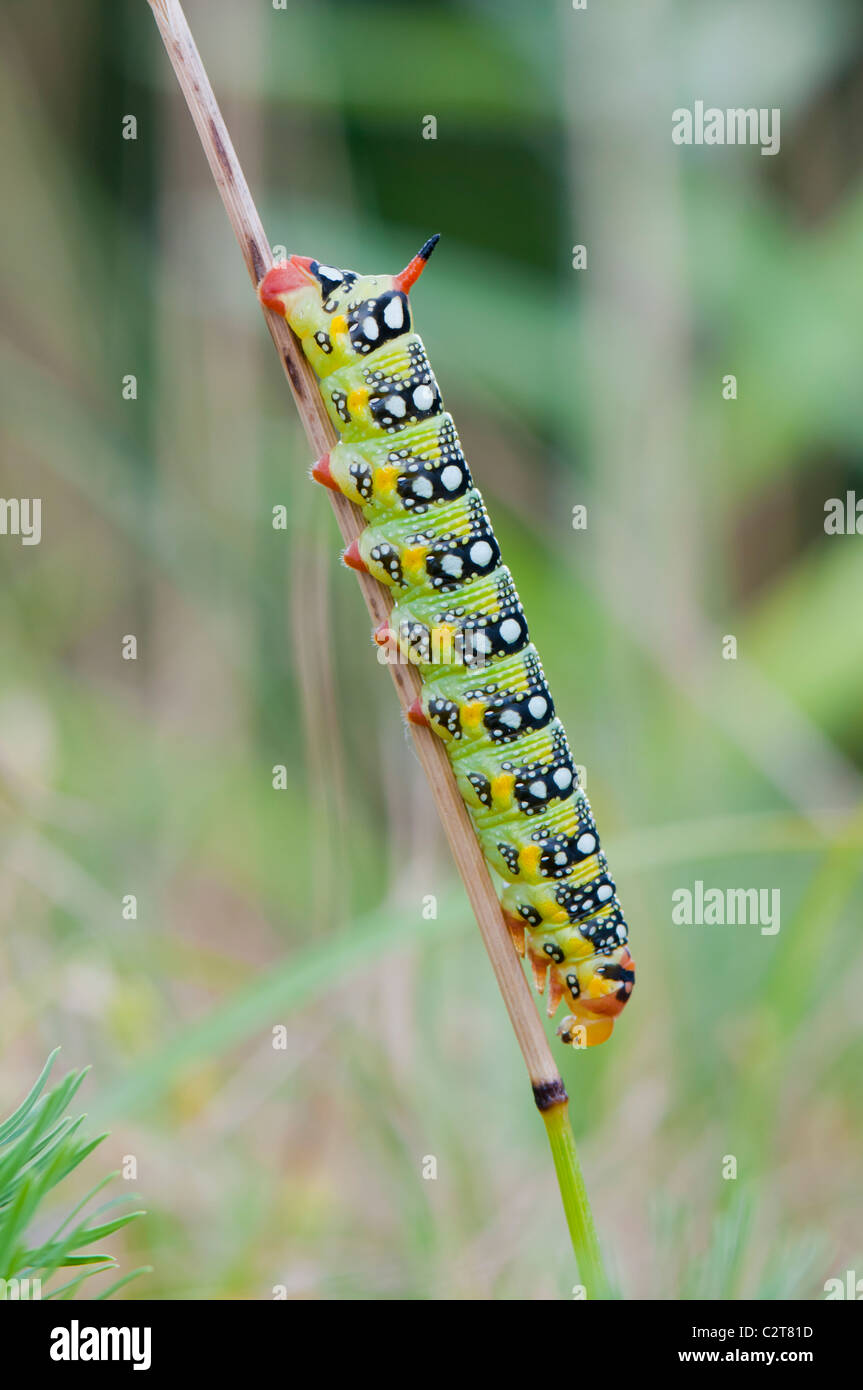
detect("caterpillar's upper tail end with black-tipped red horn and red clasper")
(258, 235), (438, 377)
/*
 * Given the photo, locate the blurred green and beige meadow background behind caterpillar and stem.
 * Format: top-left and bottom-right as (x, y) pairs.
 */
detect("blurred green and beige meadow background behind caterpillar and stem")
(0, 0), (863, 1300)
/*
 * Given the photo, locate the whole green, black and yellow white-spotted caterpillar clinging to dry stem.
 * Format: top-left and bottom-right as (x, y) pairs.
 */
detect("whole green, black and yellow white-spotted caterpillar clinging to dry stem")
(258, 236), (635, 1047)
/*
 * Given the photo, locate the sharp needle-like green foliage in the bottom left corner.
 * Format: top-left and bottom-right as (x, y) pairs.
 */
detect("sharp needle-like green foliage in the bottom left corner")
(0, 1048), (145, 1298)
